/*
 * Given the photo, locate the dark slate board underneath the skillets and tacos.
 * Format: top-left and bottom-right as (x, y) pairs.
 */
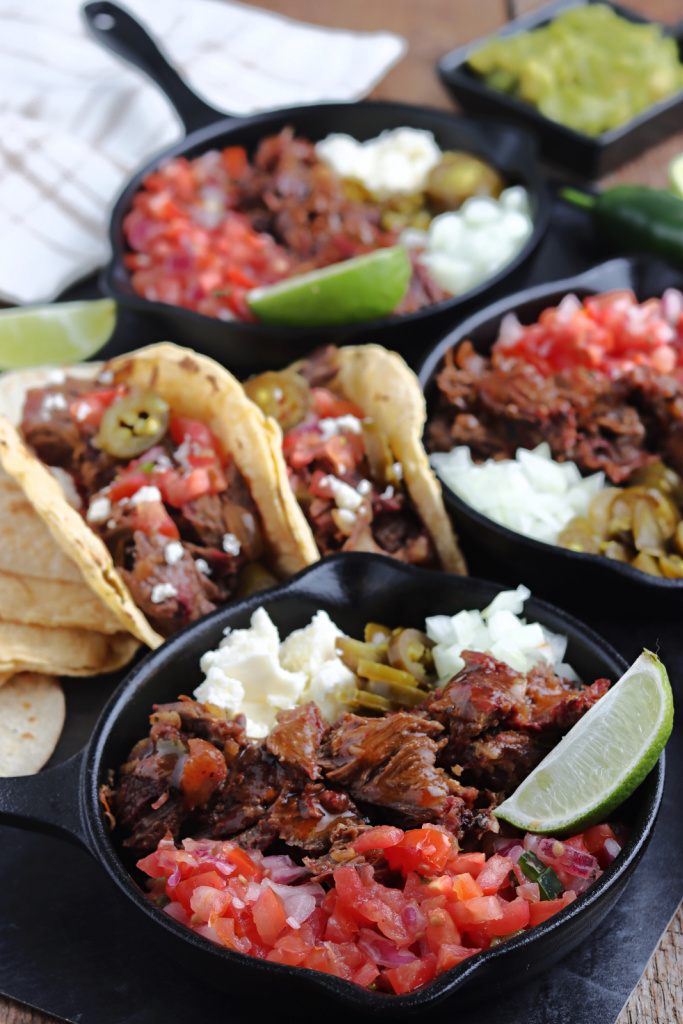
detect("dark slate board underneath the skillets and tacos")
(0, 190), (683, 1024)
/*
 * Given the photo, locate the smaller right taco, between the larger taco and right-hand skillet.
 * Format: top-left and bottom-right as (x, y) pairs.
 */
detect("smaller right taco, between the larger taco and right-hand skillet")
(245, 345), (467, 573)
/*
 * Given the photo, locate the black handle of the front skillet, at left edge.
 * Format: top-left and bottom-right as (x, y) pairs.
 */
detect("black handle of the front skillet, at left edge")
(0, 751), (90, 851)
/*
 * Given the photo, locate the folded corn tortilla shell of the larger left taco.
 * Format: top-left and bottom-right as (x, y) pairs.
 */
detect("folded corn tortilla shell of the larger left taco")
(0, 342), (318, 647)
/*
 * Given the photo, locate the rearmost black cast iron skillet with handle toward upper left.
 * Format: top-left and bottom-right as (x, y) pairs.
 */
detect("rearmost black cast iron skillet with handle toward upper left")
(83, 0), (550, 375)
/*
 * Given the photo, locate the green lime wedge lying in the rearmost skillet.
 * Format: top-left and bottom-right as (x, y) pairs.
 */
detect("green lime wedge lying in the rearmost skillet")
(247, 246), (413, 327)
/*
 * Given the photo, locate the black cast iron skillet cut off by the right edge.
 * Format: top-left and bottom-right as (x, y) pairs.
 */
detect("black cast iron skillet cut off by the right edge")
(418, 256), (683, 611)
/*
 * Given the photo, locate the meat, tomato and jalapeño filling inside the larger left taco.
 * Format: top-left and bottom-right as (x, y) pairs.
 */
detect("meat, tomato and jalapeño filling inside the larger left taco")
(22, 372), (274, 636)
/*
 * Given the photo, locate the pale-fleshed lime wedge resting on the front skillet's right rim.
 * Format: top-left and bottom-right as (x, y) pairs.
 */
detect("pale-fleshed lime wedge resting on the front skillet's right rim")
(494, 650), (674, 835)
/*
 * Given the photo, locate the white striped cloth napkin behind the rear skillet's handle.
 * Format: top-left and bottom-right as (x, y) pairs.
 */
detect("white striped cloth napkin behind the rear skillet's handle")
(0, 0), (407, 304)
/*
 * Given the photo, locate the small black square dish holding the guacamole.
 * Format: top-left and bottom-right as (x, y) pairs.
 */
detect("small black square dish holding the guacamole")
(437, 0), (683, 178)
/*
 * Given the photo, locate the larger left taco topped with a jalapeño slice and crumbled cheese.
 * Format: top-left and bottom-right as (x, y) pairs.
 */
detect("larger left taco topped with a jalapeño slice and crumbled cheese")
(0, 343), (317, 647)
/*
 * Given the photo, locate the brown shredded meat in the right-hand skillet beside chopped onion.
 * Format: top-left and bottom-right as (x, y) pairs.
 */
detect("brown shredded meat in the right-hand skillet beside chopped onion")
(426, 341), (683, 483)
